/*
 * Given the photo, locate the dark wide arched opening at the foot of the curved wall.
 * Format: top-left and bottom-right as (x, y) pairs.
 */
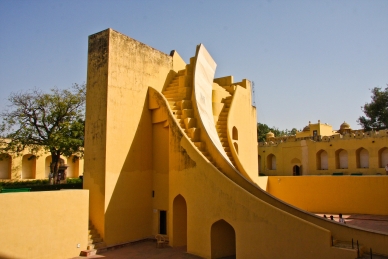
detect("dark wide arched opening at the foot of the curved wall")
(210, 219), (236, 258)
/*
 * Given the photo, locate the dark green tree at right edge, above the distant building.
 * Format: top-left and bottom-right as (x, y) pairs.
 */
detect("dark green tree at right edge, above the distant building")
(357, 87), (388, 131)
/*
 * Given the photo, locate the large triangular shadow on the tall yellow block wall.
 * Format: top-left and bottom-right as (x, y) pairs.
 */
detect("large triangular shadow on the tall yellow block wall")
(104, 96), (156, 245)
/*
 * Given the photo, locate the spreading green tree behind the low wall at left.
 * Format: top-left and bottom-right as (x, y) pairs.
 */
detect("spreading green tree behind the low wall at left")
(0, 84), (86, 184)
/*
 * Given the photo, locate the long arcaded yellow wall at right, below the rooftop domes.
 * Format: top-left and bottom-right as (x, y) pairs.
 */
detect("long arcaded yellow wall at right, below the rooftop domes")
(258, 124), (388, 176)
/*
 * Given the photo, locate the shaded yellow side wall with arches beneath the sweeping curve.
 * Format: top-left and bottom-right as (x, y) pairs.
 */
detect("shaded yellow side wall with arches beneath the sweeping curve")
(169, 135), (355, 258)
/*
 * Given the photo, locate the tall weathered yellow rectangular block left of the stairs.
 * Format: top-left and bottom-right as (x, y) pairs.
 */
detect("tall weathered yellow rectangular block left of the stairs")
(84, 29), (175, 245)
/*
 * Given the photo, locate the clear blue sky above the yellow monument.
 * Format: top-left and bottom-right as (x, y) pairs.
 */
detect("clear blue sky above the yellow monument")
(0, 0), (388, 132)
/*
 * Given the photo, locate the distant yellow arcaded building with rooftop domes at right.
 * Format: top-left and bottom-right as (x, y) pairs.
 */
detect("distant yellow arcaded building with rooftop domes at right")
(258, 121), (388, 176)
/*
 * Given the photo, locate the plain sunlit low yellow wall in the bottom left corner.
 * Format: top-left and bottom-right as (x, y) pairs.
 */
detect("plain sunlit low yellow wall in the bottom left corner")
(0, 190), (89, 259)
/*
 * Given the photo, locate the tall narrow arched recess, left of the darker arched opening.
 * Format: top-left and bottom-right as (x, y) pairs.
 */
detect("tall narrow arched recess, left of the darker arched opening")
(172, 194), (187, 247)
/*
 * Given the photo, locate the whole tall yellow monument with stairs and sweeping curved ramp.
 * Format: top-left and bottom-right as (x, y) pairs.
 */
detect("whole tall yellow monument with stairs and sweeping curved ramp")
(84, 29), (388, 259)
